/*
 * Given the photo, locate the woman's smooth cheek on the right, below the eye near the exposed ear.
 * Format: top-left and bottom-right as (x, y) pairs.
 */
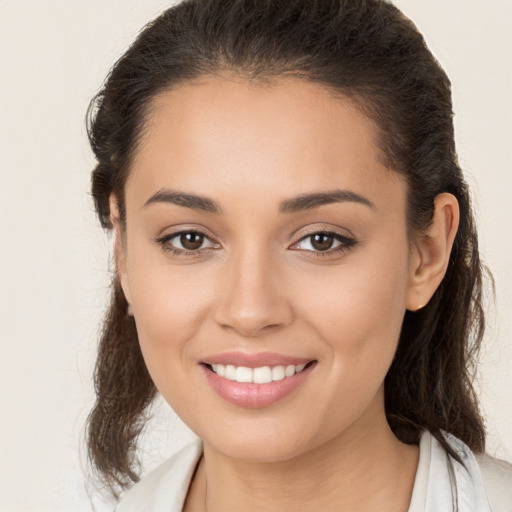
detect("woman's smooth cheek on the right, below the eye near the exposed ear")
(294, 239), (408, 404)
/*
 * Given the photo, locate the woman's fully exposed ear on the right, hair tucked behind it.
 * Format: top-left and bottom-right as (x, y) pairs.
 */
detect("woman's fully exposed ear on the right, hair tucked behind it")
(406, 193), (459, 311)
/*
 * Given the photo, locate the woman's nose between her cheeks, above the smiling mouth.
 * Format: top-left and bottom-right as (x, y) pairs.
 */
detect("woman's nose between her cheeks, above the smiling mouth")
(211, 245), (293, 337)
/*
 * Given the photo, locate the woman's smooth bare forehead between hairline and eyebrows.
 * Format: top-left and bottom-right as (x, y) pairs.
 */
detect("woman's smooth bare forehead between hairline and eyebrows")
(127, 73), (403, 212)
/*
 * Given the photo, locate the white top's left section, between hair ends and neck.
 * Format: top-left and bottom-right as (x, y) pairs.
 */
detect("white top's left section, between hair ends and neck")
(116, 439), (203, 512)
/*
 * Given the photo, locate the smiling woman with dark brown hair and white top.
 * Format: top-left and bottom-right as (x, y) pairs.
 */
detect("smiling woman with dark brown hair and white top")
(89, 0), (512, 512)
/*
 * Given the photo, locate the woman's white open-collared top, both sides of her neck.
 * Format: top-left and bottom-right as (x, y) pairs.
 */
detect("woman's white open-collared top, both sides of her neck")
(116, 432), (512, 512)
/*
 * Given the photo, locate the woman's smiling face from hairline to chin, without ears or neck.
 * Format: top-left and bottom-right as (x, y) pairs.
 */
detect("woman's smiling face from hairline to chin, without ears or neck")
(118, 78), (413, 460)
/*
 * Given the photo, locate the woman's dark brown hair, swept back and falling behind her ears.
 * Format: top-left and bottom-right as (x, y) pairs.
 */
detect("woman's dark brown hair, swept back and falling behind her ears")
(88, 0), (485, 496)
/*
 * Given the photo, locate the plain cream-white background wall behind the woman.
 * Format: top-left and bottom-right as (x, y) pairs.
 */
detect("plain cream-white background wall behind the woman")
(0, 0), (512, 512)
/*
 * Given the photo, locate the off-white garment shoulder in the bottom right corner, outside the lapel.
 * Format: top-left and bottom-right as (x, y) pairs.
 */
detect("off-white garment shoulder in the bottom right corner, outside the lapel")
(475, 454), (512, 512)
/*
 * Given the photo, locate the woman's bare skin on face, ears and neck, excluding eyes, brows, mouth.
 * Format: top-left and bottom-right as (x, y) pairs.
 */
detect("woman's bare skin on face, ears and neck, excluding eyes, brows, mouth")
(111, 77), (458, 512)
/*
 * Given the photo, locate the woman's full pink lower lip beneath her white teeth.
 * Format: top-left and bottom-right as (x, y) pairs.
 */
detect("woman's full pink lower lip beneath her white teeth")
(201, 363), (316, 409)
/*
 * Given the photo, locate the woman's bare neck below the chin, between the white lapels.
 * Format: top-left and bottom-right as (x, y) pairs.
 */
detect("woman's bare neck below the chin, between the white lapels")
(184, 402), (419, 512)
